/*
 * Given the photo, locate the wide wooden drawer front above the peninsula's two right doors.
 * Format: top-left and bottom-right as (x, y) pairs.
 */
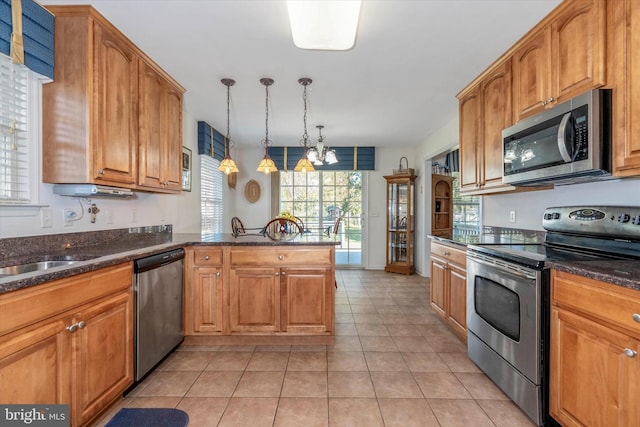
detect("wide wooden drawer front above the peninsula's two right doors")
(231, 248), (333, 266)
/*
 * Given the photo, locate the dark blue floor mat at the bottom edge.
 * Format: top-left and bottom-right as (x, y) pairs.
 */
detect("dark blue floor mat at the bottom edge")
(105, 408), (189, 427)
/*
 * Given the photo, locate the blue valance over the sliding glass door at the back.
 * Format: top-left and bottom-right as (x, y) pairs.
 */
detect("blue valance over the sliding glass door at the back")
(269, 147), (376, 171)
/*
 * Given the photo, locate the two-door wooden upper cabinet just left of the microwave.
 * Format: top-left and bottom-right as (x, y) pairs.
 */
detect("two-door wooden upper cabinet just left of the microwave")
(458, 60), (515, 194)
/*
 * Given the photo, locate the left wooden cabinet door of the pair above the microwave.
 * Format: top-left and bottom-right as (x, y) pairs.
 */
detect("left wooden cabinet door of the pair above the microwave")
(513, 28), (551, 122)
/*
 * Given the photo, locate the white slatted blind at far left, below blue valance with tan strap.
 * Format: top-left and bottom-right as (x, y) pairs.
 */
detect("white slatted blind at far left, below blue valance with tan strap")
(0, 54), (30, 204)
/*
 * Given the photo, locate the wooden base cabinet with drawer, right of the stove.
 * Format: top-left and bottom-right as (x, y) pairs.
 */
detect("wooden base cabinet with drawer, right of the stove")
(549, 270), (640, 426)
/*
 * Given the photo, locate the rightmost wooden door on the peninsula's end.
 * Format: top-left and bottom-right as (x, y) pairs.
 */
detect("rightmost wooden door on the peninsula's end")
(280, 268), (334, 333)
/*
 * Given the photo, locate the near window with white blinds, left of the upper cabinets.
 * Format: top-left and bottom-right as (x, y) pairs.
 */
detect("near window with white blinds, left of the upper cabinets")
(0, 54), (32, 205)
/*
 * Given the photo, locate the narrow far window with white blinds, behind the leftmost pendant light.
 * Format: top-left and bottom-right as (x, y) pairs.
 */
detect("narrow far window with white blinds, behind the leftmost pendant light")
(199, 155), (225, 235)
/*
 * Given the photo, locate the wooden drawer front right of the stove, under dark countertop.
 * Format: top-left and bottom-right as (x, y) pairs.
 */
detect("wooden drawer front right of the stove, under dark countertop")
(551, 270), (640, 338)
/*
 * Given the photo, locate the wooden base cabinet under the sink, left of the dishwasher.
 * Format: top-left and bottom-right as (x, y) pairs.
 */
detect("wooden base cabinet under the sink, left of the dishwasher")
(0, 263), (133, 426)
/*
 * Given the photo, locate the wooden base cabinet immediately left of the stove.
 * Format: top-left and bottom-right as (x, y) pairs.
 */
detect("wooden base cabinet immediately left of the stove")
(429, 240), (467, 342)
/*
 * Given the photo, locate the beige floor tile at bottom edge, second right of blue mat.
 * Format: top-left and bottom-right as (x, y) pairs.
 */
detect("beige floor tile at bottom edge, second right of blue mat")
(217, 397), (278, 427)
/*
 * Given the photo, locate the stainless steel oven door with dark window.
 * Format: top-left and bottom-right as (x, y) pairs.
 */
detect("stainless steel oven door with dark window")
(467, 251), (542, 385)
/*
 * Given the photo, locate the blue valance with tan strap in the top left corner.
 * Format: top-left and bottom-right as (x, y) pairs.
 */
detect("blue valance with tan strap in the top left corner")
(0, 0), (54, 79)
